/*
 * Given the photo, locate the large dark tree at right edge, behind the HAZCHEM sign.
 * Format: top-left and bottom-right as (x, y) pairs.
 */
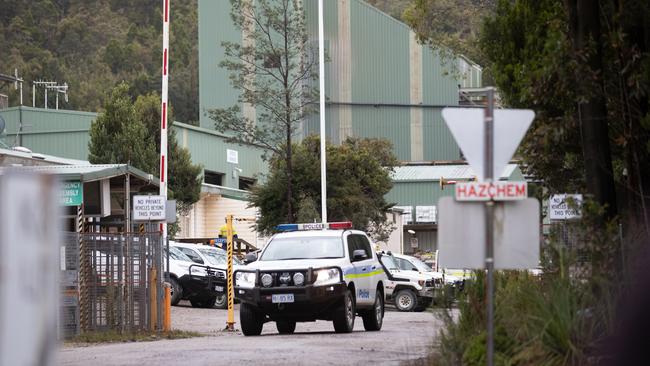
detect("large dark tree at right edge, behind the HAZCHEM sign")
(481, 0), (650, 246)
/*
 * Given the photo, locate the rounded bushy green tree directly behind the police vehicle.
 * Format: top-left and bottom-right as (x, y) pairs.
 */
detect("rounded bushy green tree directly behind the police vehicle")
(250, 136), (398, 240)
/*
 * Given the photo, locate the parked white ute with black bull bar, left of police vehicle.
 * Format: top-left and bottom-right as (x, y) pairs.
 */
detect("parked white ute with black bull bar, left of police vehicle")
(169, 242), (241, 309)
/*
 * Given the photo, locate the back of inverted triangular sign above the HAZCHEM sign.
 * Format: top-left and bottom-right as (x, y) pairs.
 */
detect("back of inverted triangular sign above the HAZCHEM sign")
(442, 108), (535, 181)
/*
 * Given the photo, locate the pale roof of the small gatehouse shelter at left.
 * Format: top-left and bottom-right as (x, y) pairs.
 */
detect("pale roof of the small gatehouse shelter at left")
(0, 164), (159, 186)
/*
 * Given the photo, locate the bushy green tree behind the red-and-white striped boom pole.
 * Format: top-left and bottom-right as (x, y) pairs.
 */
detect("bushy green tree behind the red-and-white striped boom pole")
(88, 83), (201, 211)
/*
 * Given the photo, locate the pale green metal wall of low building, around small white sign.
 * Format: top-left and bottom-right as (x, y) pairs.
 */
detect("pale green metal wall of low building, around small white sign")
(174, 123), (267, 188)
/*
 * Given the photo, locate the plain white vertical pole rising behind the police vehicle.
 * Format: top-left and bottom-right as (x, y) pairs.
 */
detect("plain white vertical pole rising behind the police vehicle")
(318, 0), (327, 224)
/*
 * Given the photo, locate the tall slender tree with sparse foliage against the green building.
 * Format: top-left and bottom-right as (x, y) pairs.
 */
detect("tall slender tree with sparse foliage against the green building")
(209, 0), (317, 222)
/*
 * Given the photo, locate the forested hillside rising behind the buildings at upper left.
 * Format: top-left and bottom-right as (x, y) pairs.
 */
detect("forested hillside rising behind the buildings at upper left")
(0, 0), (199, 123)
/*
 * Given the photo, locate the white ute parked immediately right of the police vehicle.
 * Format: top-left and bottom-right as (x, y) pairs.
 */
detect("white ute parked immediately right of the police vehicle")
(377, 252), (434, 311)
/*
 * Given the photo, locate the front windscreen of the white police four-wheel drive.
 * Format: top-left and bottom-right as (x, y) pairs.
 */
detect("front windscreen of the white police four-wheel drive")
(260, 237), (344, 261)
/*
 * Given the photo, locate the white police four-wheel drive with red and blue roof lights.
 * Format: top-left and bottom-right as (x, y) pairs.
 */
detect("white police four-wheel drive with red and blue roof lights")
(235, 223), (386, 335)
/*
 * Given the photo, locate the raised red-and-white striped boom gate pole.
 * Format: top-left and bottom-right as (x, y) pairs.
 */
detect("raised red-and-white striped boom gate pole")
(160, 0), (170, 250)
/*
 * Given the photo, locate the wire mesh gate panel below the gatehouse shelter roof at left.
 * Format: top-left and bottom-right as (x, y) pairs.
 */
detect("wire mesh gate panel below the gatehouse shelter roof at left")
(60, 232), (163, 337)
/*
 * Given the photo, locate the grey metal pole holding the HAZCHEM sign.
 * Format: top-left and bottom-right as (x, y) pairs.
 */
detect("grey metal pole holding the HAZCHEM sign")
(485, 88), (495, 366)
